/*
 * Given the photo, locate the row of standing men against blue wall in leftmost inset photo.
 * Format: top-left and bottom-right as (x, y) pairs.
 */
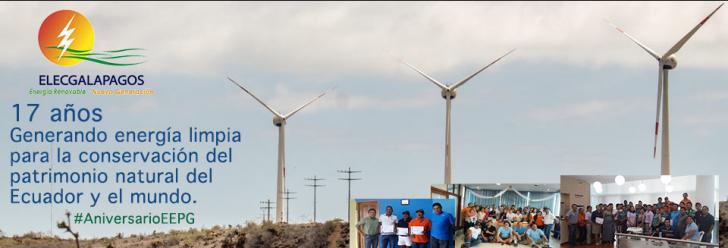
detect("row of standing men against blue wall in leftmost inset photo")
(356, 203), (456, 248)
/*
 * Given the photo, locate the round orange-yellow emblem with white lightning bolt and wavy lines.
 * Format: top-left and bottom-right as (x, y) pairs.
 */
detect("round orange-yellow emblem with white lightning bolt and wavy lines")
(38, 10), (144, 66)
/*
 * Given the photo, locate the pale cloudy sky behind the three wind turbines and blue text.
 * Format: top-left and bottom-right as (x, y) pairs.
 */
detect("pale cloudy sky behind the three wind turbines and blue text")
(0, 2), (728, 236)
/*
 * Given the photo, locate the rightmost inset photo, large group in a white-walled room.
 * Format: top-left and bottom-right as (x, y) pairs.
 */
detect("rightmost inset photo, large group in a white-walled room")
(560, 175), (724, 247)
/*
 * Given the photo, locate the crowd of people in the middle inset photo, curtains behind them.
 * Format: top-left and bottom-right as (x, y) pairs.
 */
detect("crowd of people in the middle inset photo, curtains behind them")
(461, 203), (556, 247)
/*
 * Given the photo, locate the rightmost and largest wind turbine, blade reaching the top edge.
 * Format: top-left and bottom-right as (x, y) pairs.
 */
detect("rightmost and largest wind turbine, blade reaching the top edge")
(609, 3), (723, 176)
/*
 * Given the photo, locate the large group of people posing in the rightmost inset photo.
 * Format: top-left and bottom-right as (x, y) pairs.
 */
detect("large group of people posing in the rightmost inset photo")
(564, 193), (715, 246)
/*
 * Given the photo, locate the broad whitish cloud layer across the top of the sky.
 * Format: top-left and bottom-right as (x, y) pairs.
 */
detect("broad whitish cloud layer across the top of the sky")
(5, 2), (728, 79)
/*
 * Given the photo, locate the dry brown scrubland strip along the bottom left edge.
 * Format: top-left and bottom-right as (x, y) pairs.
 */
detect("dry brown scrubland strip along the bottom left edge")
(0, 220), (349, 248)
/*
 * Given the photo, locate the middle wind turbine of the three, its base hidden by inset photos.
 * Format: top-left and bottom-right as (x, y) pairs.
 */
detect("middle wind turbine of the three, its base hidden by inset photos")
(400, 49), (515, 184)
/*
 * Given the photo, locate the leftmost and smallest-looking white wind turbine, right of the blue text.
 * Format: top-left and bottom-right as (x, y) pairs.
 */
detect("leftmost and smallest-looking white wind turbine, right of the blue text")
(228, 77), (326, 222)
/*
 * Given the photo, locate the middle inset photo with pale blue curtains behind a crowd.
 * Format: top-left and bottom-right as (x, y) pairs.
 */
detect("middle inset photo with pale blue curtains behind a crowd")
(430, 183), (562, 247)
